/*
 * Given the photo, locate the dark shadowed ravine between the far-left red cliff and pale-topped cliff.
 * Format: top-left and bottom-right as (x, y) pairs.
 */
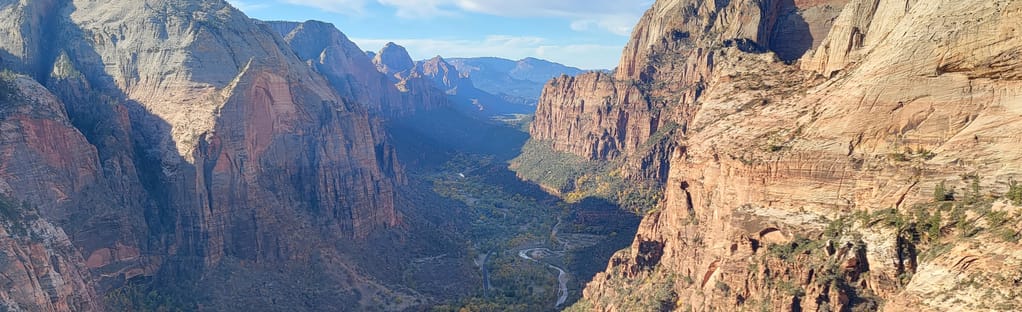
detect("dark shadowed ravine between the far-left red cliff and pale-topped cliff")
(21, 2), (191, 293)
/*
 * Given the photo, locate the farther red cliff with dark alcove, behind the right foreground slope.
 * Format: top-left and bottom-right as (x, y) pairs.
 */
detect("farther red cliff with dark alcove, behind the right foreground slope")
(530, 1), (845, 180)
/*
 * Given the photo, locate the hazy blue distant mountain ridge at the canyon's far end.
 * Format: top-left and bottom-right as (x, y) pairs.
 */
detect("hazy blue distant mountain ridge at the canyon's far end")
(448, 57), (586, 106)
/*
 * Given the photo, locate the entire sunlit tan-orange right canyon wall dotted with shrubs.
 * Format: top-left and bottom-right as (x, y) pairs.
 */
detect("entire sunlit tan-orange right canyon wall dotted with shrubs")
(531, 0), (1022, 311)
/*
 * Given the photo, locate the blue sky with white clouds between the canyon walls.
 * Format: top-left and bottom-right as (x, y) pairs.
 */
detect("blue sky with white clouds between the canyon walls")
(229, 0), (652, 70)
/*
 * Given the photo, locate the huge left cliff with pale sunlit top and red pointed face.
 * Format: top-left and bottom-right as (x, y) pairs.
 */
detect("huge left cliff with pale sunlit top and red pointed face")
(50, 1), (402, 266)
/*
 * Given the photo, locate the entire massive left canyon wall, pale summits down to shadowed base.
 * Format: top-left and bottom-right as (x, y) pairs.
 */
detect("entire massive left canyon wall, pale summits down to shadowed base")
(0, 0), (463, 310)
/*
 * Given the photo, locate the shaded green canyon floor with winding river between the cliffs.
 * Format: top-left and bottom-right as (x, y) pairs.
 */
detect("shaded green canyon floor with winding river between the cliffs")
(390, 109), (639, 311)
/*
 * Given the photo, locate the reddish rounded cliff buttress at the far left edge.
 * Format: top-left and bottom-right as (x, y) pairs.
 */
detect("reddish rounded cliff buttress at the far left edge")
(0, 77), (101, 311)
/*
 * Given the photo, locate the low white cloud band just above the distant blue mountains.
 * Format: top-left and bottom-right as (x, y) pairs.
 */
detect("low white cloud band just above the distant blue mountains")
(352, 36), (622, 69)
